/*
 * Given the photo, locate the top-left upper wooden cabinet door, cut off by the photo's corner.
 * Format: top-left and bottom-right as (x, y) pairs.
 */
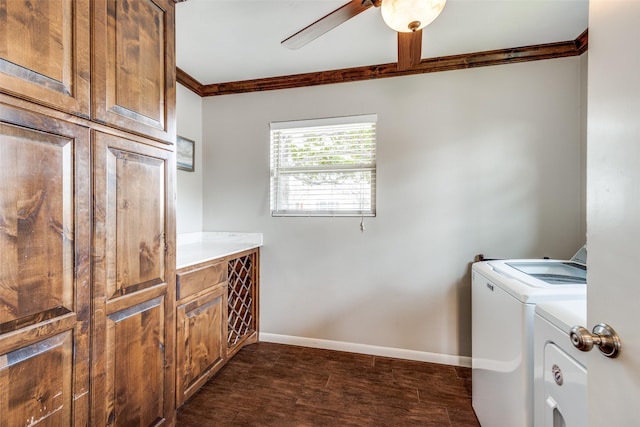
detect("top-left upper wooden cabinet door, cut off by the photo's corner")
(0, 0), (90, 117)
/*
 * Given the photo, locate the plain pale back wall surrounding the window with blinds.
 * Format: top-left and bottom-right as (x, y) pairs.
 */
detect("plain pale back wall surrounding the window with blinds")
(198, 57), (585, 362)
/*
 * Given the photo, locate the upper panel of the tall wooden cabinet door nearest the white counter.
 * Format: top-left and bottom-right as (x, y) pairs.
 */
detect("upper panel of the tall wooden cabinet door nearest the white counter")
(94, 132), (172, 299)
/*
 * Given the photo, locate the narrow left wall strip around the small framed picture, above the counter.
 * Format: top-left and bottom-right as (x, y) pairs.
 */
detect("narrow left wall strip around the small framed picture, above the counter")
(176, 84), (202, 234)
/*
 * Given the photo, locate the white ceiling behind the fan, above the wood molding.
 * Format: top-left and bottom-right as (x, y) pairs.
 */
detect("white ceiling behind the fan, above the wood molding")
(176, 0), (588, 85)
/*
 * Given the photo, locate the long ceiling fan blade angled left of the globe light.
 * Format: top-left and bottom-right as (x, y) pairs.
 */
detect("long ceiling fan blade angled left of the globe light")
(281, 0), (372, 49)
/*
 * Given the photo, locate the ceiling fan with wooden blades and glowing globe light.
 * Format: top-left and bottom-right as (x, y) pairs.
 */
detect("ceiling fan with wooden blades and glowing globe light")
(281, 0), (447, 71)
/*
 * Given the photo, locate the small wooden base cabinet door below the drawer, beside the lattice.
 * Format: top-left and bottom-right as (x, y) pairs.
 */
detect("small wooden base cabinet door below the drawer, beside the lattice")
(176, 284), (227, 405)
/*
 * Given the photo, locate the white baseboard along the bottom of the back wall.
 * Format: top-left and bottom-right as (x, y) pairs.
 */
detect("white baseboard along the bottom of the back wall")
(260, 332), (471, 368)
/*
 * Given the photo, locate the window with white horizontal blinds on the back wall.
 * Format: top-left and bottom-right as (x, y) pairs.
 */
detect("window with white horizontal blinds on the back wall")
(271, 114), (377, 216)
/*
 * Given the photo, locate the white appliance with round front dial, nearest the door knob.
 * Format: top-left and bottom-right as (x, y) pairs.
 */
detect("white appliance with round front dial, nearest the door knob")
(533, 298), (587, 427)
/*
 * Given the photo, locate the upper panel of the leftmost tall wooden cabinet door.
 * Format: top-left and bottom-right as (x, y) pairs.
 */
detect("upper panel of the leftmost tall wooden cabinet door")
(0, 124), (74, 325)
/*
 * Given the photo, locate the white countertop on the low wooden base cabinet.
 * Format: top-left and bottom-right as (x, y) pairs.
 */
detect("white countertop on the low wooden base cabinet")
(176, 232), (262, 269)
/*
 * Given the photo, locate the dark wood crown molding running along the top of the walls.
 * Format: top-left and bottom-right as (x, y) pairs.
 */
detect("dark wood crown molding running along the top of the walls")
(176, 29), (589, 97)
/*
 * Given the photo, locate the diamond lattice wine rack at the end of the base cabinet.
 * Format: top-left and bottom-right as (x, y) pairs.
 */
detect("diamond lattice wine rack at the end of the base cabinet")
(227, 249), (259, 357)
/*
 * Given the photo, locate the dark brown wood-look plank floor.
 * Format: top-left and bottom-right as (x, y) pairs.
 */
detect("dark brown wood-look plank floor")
(177, 343), (479, 427)
